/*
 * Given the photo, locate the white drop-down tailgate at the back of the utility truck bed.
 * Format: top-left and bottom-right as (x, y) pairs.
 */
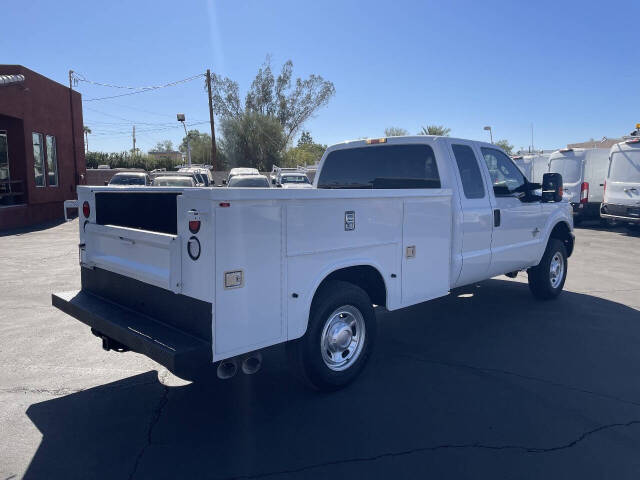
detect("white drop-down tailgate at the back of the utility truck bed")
(81, 223), (182, 293)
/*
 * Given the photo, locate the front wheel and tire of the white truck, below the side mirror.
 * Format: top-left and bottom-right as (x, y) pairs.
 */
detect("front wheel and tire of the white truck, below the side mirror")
(527, 238), (567, 300)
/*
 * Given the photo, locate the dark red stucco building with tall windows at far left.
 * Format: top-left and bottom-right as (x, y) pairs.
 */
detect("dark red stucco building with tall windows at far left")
(0, 65), (85, 230)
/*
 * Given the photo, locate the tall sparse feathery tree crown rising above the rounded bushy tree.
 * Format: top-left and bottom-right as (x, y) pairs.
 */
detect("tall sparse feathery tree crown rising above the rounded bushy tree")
(212, 56), (335, 144)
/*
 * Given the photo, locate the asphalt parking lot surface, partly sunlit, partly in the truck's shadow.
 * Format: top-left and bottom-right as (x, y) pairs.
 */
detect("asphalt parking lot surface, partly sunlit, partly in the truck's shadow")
(0, 221), (640, 479)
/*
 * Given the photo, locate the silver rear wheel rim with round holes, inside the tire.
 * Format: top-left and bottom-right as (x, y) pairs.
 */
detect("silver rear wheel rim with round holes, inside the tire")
(320, 305), (366, 372)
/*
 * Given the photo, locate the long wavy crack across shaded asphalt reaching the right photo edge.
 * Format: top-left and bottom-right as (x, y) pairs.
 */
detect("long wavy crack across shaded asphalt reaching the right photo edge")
(218, 420), (640, 480)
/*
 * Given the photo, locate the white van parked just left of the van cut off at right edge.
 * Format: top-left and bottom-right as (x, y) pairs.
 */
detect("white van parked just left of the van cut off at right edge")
(549, 148), (609, 223)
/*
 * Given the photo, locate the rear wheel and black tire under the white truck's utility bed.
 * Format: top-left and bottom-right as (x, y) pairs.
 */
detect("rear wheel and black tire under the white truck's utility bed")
(287, 281), (377, 391)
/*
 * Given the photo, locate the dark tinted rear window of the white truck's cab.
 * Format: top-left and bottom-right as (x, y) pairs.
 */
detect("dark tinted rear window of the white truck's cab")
(318, 144), (441, 189)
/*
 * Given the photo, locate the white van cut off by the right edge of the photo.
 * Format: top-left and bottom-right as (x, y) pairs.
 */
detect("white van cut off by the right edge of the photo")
(600, 138), (640, 227)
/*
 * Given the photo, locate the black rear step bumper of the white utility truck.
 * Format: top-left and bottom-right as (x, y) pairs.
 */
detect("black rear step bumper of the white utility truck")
(51, 290), (212, 379)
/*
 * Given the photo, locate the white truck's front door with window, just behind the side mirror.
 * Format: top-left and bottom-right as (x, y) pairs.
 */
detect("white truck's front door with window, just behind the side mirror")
(480, 147), (544, 276)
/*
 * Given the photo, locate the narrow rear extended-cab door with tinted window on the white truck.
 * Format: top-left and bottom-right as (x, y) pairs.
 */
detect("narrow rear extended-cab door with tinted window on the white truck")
(447, 139), (493, 286)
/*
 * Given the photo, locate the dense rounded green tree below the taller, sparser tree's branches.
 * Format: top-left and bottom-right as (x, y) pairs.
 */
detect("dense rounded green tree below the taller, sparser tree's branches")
(220, 111), (287, 172)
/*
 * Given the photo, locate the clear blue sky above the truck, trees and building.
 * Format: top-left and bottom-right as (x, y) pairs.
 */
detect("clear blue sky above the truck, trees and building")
(5, 0), (640, 151)
